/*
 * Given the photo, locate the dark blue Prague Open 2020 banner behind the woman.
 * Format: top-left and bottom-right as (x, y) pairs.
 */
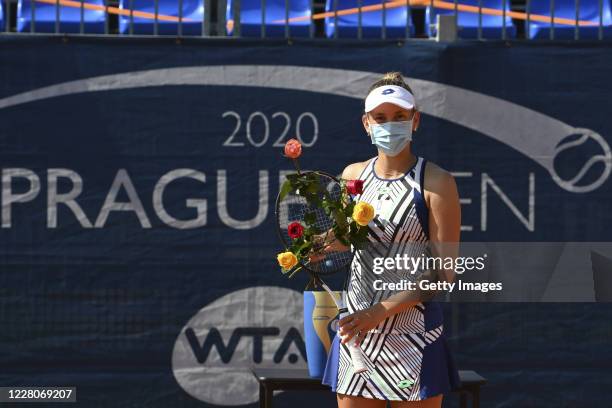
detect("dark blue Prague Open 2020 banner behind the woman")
(0, 35), (612, 407)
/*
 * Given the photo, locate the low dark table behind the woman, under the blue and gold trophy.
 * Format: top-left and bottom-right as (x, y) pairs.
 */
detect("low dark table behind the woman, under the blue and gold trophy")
(252, 368), (487, 408)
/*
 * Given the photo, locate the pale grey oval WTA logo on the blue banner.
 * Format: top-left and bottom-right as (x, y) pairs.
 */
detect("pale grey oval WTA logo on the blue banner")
(172, 286), (306, 405)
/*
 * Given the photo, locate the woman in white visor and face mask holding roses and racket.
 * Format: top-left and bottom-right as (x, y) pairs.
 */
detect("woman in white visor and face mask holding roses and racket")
(323, 72), (461, 408)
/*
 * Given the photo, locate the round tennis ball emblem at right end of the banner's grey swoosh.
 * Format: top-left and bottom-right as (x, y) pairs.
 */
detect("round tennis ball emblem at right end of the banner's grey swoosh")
(550, 128), (612, 193)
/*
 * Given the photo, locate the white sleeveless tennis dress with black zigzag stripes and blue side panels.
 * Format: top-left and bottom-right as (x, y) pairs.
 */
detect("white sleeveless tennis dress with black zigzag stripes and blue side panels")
(322, 157), (459, 401)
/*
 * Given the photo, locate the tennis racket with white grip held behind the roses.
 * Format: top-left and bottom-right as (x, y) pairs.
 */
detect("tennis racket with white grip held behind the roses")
(275, 171), (368, 373)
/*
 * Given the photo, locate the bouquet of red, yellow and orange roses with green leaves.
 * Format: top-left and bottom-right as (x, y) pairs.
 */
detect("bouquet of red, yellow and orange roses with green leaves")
(277, 139), (374, 277)
